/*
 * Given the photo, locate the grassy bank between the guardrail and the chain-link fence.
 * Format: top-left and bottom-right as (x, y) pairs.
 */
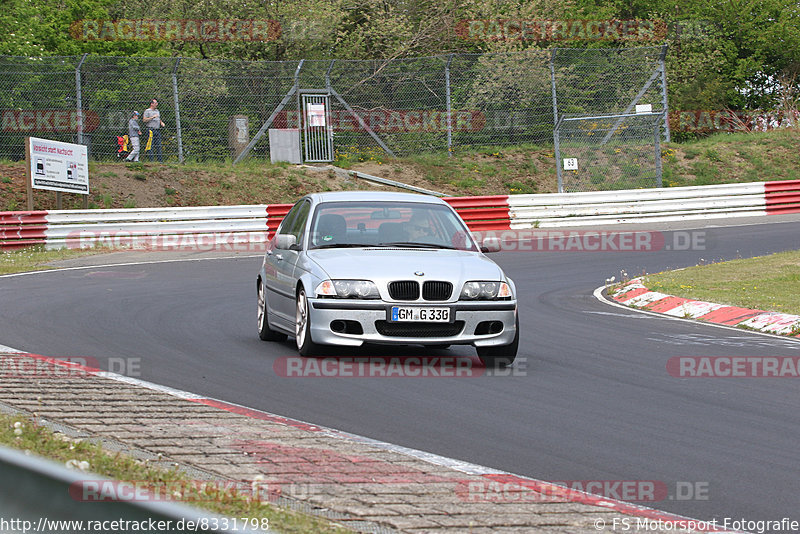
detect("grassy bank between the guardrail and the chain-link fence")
(0, 129), (800, 211)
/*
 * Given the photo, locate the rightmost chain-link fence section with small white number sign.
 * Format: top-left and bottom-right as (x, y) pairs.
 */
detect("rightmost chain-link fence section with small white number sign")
(551, 47), (669, 192)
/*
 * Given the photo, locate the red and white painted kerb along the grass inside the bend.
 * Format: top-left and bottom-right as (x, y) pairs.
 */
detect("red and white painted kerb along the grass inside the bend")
(609, 278), (800, 337)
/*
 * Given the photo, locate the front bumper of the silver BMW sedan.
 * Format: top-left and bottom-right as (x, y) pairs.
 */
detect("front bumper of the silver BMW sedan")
(309, 298), (517, 347)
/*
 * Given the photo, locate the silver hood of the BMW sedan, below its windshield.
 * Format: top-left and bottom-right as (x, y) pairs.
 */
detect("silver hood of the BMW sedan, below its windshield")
(308, 248), (504, 282)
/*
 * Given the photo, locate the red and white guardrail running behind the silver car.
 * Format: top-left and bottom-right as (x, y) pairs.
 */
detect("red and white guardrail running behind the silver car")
(0, 180), (800, 249)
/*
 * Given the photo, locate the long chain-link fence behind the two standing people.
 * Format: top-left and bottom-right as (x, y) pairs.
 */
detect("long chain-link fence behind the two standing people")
(0, 47), (668, 190)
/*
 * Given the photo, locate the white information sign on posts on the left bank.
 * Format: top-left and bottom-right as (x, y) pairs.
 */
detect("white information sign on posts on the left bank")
(28, 137), (89, 195)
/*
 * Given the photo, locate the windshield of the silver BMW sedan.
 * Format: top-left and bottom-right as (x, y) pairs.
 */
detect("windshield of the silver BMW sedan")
(309, 201), (476, 250)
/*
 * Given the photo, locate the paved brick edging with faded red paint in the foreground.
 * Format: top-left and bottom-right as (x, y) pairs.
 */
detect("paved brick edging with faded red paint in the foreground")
(0, 353), (712, 534)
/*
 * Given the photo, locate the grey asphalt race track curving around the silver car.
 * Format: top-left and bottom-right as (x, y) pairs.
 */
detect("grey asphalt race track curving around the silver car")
(0, 218), (800, 520)
